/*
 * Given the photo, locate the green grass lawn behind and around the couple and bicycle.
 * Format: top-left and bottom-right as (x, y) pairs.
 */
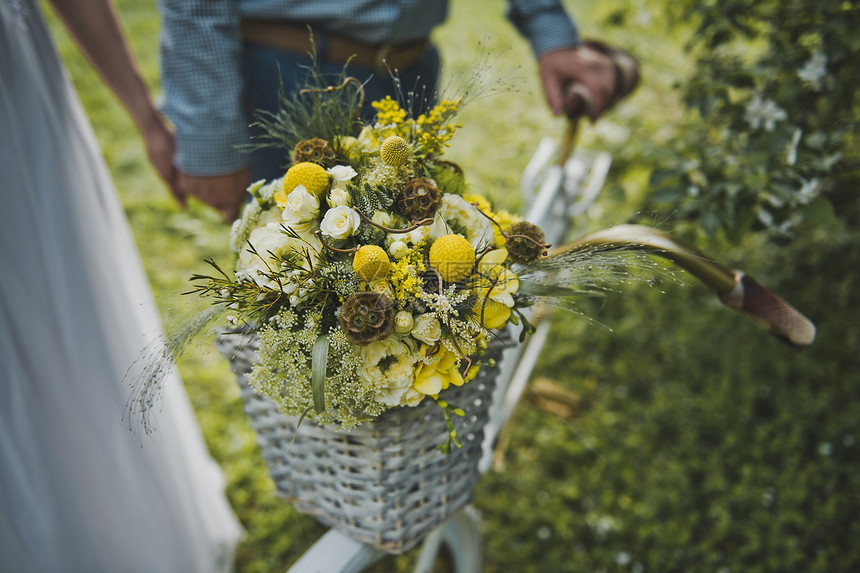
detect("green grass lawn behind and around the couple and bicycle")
(51, 0), (860, 573)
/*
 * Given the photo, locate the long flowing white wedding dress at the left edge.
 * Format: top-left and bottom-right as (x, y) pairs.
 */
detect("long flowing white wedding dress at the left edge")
(0, 0), (242, 573)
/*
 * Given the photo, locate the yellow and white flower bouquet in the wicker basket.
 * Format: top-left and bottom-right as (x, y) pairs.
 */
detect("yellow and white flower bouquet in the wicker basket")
(192, 81), (549, 446)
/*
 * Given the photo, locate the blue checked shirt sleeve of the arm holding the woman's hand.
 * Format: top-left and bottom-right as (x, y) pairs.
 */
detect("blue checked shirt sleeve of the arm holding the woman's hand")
(159, 0), (248, 175)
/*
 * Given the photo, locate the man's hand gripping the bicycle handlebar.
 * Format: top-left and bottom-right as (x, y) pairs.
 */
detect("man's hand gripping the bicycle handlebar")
(538, 45), (617, 121)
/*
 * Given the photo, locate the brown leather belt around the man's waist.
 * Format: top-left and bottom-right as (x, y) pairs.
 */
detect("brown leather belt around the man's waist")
(239, 20), (430, 72)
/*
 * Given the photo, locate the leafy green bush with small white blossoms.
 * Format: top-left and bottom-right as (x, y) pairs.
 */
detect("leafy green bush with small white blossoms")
(648, 0), (860, 239)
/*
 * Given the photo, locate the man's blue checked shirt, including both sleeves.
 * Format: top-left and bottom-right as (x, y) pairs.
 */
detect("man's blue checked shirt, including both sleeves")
(158, 0), (580, 175)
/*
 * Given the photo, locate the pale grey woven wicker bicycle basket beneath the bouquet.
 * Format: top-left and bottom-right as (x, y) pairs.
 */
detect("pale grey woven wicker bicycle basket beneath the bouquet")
(218, 333), (503, 553)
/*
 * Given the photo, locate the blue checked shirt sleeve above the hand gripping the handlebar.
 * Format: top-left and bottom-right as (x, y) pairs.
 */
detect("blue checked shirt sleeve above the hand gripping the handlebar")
(508, 0), (582, 57)
